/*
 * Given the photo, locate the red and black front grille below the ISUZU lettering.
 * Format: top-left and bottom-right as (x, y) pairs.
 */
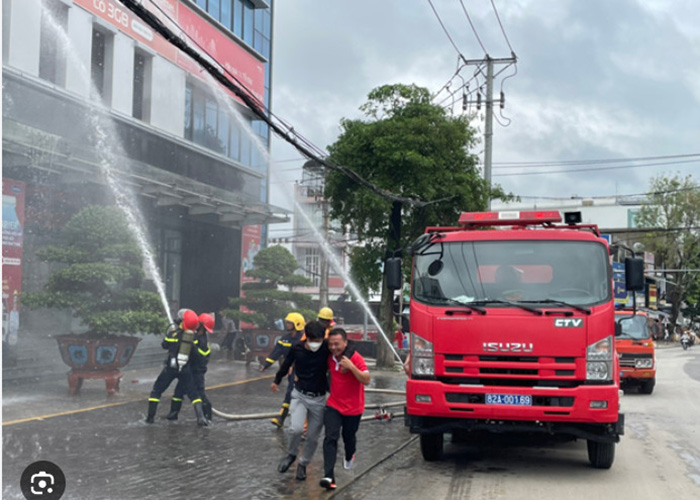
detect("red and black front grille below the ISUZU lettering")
(436, 354), (580, 386)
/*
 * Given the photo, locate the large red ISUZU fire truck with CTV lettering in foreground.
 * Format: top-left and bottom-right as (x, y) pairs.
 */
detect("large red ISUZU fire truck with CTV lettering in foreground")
(386, 211), (644, 469)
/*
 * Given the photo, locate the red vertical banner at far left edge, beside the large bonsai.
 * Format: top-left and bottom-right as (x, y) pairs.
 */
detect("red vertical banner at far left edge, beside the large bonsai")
(2, 179), (25, 345)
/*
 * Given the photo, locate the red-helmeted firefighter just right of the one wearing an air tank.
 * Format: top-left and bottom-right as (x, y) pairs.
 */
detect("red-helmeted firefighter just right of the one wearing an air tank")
(165, 313), (214, 421)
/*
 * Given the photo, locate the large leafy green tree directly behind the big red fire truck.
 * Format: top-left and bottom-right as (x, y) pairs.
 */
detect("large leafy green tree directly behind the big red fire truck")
(324, 84), (508, 366)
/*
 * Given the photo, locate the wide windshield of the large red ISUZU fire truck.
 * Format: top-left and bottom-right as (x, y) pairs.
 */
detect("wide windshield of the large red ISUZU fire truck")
(413, 240), (611, 307)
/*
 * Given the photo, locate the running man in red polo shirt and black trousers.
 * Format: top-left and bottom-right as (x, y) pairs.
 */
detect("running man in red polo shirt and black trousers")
(319, 328), (370, 490)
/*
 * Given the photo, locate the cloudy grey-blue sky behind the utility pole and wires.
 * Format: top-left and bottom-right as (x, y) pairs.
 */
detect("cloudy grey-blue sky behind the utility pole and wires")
(272, 0), (700, 227)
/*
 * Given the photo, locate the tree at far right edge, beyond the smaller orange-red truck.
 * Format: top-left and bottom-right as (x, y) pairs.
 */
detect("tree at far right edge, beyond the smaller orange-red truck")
(636, 174), (700, 324)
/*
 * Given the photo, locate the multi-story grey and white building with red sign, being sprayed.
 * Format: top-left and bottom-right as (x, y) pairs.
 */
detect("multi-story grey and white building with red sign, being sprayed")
(2, 0), (287, 335)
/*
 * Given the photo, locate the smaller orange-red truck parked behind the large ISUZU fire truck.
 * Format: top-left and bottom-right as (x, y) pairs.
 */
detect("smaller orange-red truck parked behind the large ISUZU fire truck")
(615, 309), (656, 394)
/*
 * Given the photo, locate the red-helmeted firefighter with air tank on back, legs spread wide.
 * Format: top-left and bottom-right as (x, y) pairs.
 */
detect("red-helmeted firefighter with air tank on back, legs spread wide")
(146, 309), (209, 426)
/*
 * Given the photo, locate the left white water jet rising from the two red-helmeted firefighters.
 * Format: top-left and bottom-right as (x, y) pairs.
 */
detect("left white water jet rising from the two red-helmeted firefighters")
(36, 0), (173, 323)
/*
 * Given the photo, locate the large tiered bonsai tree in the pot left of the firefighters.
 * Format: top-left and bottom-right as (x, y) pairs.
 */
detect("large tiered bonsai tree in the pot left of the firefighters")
(23, 205), (168, 336)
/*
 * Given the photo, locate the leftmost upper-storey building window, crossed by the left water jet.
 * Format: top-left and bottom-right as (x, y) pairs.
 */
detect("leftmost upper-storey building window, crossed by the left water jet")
(38, 0), (68, 86)
